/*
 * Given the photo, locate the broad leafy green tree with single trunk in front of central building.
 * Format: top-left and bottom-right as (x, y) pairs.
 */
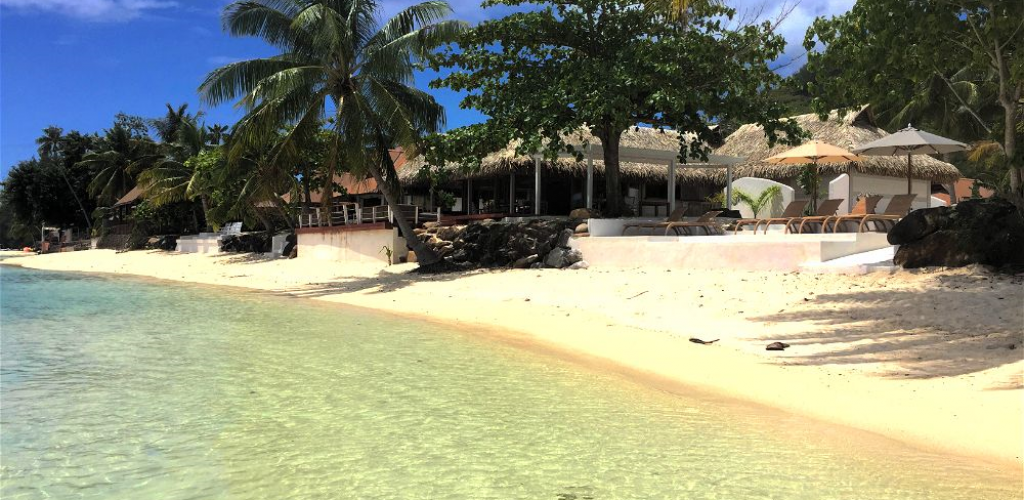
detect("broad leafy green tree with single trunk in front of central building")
(431, 0), (801, 216)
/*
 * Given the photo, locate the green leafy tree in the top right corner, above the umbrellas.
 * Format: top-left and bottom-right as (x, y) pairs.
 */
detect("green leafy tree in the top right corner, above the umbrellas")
(804, 0), (1024, 195)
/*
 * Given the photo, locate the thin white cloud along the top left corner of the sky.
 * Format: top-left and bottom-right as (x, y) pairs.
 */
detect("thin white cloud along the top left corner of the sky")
(0, 0), (178, 22)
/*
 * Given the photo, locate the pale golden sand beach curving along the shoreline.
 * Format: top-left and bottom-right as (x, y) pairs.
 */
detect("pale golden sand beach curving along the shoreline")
(0, 250), (1024, 470)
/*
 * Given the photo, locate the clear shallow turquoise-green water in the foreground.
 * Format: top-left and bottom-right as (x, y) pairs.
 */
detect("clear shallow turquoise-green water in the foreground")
(0, 267), (1020, 500)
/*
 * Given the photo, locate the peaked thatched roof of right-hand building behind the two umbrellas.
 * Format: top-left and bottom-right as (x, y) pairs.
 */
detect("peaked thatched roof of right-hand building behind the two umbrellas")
(715, 107), (961, 184)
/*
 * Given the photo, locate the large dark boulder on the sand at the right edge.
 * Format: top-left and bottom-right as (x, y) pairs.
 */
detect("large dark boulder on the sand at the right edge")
(889, 199), (1024, 268)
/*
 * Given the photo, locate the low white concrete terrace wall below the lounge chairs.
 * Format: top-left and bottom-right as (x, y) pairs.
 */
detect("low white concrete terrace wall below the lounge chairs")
(571, 233), (889, 272)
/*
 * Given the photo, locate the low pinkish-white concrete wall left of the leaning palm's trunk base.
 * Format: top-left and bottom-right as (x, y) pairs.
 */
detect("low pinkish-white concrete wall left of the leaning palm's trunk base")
(298, 227), (408, 263)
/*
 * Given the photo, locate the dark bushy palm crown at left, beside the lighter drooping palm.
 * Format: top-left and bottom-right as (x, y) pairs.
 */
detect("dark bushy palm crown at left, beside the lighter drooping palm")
(77, 125), (161, 203)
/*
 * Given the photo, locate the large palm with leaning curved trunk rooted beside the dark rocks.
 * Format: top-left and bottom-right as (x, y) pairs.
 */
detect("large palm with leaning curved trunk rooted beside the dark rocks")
(200, 0), (466, 265)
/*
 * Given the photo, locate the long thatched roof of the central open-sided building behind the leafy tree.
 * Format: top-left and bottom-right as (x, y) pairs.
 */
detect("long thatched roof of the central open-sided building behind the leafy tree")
(399, 127), (725, 184)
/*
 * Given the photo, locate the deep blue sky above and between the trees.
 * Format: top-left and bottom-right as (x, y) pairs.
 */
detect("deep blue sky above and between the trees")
(0, 0), (854, 176)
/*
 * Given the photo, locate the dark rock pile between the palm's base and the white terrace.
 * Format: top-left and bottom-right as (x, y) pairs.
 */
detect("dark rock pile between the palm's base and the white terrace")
(418, 218), (587, 268)
